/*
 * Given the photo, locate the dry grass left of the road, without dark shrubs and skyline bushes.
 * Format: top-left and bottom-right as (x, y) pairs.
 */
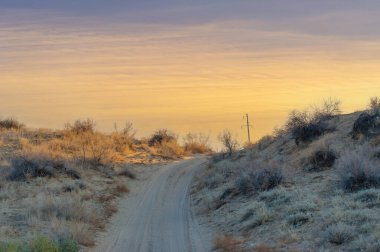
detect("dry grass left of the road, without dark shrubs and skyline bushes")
(0, 129), (177, 251)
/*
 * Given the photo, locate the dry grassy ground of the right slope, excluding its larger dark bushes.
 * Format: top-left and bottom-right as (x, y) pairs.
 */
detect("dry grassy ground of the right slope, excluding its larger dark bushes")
(192, 112), (380, 251)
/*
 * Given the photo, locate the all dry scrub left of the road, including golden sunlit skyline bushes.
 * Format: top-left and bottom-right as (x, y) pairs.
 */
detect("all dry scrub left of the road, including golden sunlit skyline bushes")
(0, 119), (211, 251)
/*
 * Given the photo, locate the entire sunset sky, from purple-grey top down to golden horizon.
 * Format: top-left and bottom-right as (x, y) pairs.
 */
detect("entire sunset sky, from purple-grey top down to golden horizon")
(0, 0), (380, 146)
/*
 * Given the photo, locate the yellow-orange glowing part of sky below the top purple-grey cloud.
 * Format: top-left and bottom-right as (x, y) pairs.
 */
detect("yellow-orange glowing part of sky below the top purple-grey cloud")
(0, 8), (380, 148)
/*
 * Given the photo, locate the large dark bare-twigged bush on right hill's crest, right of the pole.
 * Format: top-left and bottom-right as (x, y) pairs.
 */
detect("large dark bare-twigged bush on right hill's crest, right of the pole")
(285, 98), (340, 145)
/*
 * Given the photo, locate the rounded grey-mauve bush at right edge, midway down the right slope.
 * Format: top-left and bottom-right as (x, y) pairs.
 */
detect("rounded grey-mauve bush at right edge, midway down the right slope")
(337, 147), (380, 191)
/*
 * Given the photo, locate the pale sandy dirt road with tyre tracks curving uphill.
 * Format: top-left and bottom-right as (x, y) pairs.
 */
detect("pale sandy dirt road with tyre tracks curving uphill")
(94, 157), (212, 252)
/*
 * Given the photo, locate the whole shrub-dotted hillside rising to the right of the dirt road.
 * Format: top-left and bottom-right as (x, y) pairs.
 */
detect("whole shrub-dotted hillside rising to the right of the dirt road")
(192, 109), (380, 251)
